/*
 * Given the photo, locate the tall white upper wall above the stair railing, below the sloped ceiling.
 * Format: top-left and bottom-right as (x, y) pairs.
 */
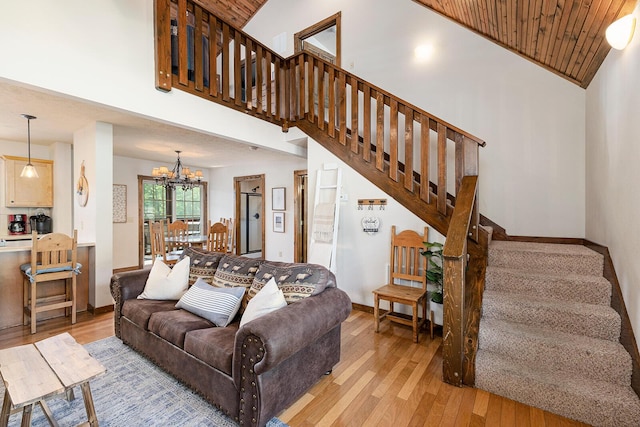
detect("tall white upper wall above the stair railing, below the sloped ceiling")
(245, 0), (585, 237)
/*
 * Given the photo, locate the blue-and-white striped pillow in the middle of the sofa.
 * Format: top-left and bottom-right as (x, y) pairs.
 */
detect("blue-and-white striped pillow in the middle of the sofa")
(176, 278), (245, 327)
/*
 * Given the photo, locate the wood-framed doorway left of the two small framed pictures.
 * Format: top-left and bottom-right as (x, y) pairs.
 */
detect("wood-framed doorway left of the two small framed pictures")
(234, 175), (265, 258)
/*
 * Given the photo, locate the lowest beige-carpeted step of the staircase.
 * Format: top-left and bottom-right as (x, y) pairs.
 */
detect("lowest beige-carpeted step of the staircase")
(476, 350), (640, 426)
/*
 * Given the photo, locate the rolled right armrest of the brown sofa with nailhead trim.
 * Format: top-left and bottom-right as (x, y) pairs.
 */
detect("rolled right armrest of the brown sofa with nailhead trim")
(233, 288), (351, 378)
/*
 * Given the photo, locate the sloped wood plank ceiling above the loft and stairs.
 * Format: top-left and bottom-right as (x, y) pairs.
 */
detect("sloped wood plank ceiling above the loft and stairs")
(195, 0), (637, 88)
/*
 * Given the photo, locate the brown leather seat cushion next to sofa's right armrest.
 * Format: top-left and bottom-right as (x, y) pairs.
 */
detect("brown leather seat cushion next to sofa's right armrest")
(184, 322), (238, 375)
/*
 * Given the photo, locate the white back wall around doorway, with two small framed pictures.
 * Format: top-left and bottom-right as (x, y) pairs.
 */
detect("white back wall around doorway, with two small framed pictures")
(209, 156), (307, 262)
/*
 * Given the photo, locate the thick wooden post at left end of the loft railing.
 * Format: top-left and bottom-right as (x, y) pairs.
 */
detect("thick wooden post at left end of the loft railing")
(154, 0), (171, 92)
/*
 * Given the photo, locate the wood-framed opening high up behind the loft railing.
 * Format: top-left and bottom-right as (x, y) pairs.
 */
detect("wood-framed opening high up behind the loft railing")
(293, 12), (341, 67)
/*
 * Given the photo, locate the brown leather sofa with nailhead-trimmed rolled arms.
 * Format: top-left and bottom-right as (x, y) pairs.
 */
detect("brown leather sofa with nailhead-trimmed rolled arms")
(111, 251), (351, 426)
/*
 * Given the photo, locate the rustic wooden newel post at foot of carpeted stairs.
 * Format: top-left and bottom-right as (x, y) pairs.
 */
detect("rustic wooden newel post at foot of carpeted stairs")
(442, 251), (466, 387)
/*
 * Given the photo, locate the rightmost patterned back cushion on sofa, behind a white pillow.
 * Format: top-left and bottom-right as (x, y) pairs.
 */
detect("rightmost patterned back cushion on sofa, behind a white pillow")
(247, 262), (331, 304)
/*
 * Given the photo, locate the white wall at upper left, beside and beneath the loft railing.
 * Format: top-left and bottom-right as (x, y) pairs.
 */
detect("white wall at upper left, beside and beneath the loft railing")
(0, 0), (304, 160)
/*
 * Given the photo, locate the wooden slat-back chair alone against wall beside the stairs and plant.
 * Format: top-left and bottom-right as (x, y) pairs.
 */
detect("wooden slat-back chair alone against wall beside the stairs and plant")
(373, 225), (428, 342)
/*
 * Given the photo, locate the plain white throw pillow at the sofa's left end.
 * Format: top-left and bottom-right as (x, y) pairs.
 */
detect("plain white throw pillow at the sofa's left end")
(138, 256), (191, 300)
